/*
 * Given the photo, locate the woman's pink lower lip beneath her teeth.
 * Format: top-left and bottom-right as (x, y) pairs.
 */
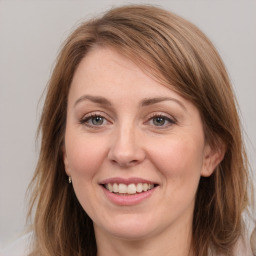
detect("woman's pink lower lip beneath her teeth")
(102, 186), (157, 206)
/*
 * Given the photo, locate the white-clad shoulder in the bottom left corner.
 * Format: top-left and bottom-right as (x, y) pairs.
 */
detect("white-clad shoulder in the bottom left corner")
(0, 232), (33, 256)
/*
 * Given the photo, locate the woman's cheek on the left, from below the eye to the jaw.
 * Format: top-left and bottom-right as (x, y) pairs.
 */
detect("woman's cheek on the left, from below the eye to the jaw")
(65, 133), (106, 216)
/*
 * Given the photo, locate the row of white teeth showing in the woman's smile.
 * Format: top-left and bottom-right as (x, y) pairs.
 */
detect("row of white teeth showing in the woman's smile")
(105, 183), (154, 195)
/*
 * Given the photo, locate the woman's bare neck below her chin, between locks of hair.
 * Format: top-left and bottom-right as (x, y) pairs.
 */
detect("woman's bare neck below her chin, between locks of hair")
(95, 220), (193, 256)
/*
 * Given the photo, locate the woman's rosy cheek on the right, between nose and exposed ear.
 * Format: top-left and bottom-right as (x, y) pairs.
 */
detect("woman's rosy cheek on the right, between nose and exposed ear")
(148, 138), (203, 187)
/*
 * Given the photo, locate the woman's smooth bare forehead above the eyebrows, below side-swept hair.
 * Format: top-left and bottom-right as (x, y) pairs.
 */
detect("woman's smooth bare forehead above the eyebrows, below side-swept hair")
(70, 47), (184, 101)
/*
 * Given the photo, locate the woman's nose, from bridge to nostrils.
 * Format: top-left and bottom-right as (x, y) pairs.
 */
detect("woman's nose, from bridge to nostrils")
(108, 125), (146, 167)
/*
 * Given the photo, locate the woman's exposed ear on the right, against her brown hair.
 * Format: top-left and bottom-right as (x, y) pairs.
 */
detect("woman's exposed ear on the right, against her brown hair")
(201, 142), (226, 177)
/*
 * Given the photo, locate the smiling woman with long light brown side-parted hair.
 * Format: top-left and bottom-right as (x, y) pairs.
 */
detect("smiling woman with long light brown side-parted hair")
(24, 6), (252, 256)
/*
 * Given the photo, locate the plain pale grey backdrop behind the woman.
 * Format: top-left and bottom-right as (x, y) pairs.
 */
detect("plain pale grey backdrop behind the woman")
(0, 0), (256, 247)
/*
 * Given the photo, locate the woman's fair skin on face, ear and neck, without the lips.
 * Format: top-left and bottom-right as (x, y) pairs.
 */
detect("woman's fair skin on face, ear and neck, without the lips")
(63, 47), (221, 256)
